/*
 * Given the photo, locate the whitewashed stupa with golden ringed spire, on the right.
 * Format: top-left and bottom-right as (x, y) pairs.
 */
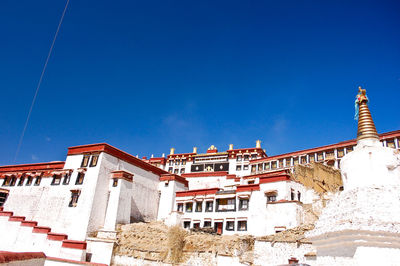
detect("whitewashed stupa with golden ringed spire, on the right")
(307, 87), (400, 265)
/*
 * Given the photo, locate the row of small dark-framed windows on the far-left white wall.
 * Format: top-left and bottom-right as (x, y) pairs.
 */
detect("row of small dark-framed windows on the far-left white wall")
(2, 173), (85, 187)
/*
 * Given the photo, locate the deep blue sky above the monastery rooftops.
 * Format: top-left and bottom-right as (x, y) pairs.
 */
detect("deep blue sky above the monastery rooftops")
(0, 0), (400, 165)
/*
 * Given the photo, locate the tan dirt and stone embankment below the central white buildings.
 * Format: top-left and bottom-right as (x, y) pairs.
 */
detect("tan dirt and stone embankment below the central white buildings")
(114, 222), (254, 263)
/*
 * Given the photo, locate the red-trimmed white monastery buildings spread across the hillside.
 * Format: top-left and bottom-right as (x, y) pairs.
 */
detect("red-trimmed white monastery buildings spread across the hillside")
(0, 131), (400, 264)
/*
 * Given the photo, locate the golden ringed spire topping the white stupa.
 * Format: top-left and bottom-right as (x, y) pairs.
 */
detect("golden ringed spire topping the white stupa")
(356, 87), (379, 140)
